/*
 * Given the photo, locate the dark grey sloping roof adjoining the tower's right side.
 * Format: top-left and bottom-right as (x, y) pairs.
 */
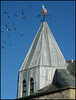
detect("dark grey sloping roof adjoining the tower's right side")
(31, 61), (76, 95)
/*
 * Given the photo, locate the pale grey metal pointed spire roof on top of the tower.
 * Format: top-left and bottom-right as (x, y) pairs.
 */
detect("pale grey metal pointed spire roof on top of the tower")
(20, 22), (66, 71)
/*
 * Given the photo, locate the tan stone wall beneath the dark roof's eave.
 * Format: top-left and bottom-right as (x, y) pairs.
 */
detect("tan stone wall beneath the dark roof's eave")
(29, 89), (75, 100)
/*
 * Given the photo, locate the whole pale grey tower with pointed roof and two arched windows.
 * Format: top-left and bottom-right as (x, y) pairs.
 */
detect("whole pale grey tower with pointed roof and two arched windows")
(17, 4), (66, 98)
